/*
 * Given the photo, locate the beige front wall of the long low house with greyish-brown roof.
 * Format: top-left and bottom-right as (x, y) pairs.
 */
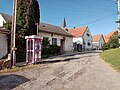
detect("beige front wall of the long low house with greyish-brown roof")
(39, 32), (73, 52)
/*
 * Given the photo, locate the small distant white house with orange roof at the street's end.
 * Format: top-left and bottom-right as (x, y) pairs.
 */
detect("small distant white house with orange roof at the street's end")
(92, 34), (105, 50)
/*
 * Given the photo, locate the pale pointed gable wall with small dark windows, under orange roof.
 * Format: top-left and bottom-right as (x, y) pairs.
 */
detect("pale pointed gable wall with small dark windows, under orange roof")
(83, 28), (92, 50)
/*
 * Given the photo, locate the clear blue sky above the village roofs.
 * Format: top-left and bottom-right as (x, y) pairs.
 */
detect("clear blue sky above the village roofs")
(0, 0), (117, 34)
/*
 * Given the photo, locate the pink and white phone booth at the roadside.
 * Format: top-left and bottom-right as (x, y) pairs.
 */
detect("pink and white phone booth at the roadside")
(25, 35), (43, 64)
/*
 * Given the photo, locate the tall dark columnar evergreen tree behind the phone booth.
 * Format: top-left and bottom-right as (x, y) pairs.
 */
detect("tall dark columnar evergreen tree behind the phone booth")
(16, 0), (40, 61)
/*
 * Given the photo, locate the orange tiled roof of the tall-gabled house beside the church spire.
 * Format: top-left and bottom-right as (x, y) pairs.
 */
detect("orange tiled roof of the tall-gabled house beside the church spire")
(68, 26), (88, 37)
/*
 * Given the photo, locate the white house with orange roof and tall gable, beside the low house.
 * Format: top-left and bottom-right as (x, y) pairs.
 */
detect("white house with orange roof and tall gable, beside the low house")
(68, 26), (92, 51)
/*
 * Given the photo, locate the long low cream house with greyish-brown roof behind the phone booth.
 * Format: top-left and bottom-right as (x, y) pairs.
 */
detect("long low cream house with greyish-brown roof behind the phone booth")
(39, 23), (73, 52)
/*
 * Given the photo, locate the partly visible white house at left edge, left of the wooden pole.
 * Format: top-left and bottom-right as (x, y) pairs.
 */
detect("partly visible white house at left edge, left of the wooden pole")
(0, 13), (12, 58)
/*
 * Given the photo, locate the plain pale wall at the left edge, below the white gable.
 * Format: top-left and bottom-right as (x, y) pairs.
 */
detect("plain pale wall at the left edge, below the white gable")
(0, 34), (8, 58)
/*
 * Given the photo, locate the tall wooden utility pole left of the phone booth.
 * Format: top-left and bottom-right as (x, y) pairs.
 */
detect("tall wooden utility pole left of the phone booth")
(11, 0), (17, 67)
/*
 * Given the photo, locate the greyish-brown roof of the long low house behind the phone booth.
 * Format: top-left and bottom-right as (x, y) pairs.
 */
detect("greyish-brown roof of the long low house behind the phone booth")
(39, 23), (73, 37)
